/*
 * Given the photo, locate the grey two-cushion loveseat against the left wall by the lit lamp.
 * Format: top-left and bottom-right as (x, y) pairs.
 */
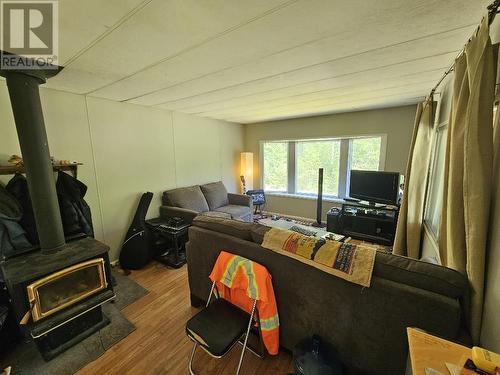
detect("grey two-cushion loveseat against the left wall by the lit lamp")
(160, 181), (253, 223)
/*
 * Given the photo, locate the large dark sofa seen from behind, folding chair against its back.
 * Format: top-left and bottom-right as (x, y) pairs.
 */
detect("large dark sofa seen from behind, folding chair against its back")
(187, 216), (468, 375)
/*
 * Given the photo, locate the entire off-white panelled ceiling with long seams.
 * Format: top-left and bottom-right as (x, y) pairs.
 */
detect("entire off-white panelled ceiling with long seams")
(47, 0), (489, 123)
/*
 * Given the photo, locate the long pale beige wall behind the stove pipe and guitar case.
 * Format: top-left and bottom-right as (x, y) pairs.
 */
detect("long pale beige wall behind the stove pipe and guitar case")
(0, 82), (244, 260)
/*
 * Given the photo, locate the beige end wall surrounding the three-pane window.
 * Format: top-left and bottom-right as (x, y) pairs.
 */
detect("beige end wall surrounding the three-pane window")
(245, 105), (416, 220)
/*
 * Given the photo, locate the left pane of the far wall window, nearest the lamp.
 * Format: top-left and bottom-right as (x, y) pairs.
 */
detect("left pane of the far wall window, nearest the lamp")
(263, 142), (288, 192)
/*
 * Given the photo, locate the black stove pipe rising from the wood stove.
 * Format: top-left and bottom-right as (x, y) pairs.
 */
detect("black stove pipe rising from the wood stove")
(0, 56), (65, 254)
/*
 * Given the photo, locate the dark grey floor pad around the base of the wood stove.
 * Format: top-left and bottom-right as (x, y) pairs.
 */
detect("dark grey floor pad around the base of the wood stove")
(0, 270), (148, 375)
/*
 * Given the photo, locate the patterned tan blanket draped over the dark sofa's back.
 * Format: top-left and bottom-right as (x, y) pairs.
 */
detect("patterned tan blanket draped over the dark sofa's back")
(262, 228), (376, 287)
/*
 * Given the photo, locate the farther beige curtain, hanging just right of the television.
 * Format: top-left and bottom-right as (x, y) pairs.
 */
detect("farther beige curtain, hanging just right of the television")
(393, 97), (435, 258)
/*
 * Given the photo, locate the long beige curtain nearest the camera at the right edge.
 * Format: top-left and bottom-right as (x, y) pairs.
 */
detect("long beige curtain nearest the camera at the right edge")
(439, 17), (495, 342)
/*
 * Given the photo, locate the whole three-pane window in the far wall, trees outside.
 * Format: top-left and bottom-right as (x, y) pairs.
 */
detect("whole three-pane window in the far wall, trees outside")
(262, 136), (385, 197)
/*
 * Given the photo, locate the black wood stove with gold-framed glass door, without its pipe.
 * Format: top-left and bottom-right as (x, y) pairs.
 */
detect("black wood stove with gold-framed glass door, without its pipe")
(0, 237), (115, 360)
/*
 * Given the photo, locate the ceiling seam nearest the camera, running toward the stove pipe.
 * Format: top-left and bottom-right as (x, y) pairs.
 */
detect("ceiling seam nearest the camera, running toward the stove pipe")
(86, 0), (301, 95)
